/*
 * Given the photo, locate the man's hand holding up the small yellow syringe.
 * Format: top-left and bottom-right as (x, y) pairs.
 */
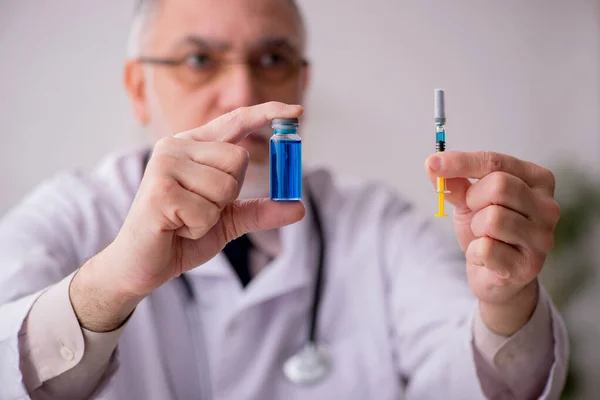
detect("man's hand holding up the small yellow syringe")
(425, 151), (560, 336)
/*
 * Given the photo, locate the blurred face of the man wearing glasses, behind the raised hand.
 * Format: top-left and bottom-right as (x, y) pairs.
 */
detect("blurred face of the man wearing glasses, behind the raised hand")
(130, 0), (308, 166)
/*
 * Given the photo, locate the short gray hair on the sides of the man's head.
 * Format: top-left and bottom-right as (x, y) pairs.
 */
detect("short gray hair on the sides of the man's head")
(127, 0), (306, 58)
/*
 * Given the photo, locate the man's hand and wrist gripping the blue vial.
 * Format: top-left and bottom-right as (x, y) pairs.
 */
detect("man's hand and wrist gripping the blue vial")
(70, 102), (305, 331)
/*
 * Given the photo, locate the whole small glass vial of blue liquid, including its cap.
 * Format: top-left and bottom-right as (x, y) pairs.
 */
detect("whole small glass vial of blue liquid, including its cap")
(269, 118), (302, 201)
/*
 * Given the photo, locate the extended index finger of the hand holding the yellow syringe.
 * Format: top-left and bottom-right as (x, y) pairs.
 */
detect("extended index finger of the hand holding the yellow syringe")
(427, 151), (555, 195)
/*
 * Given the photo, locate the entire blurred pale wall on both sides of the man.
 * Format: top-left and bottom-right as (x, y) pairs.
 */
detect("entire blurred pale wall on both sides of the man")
(0, 0), (600, 393)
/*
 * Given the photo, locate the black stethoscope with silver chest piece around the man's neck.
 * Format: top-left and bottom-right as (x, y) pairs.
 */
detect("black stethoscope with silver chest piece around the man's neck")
(177, 183), (331, 392)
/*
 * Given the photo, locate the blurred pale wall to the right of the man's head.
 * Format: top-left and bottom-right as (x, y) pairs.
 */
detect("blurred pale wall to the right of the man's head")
(302, 0), (600, 230)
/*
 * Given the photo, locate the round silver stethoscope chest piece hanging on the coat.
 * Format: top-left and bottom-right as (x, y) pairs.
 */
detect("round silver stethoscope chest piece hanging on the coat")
(283, 343), (331, 386)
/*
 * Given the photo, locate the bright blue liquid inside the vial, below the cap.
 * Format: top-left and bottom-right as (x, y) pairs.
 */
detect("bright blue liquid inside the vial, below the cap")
(270, 135), (302, 201)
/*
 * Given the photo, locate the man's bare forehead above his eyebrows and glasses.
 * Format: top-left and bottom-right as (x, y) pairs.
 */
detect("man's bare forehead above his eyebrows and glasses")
(155, 0), (303, 47)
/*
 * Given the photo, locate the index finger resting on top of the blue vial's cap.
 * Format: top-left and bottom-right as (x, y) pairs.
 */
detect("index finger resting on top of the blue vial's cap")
(175, 101), (303, 144)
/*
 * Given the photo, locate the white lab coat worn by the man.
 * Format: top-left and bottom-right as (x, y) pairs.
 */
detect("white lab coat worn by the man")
(0, 150), (566, 400)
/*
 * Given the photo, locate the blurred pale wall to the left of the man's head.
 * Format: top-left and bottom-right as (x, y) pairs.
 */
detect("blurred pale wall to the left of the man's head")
(0, 0), (139, 215)
